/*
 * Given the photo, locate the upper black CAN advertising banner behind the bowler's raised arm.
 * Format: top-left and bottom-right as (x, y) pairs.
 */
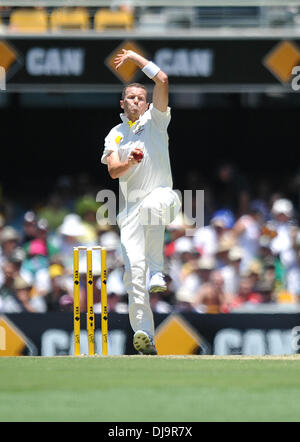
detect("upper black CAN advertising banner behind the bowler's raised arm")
(0, 36), (300, 92)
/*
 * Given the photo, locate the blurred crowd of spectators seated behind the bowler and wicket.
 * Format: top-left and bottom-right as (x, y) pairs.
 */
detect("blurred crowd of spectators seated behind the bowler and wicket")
(0, 165), (300, 313)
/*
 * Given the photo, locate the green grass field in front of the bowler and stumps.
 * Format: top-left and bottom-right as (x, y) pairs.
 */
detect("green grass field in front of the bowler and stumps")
(0, 355), (300, 422)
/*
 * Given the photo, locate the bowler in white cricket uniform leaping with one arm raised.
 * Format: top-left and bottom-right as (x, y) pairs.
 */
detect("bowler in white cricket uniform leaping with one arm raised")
(101, 49), (180, 354)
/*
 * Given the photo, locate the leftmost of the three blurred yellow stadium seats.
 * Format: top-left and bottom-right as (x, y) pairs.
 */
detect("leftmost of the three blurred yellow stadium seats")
(9, 9), (48, 32)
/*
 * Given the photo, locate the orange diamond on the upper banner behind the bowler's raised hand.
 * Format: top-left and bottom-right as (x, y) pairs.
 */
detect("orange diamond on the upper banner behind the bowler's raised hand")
(105, 41), (146, 83)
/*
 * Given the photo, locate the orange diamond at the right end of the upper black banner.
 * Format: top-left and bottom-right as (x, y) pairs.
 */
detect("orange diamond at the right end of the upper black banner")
(263, 41), (300, 83)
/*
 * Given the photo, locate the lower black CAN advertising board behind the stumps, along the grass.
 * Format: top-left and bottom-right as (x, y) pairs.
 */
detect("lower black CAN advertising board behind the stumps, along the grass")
(0, 312), (300, 357)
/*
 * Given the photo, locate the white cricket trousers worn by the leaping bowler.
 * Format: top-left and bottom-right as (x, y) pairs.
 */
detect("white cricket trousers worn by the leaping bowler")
(120, 187), (181, 337)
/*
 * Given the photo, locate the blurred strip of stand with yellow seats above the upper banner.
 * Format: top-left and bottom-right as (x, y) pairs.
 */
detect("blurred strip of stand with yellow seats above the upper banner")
(0, 0), (300, 32)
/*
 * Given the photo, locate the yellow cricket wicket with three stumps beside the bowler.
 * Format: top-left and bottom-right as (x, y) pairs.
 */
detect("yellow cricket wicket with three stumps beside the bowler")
(73, 246), (108, 356)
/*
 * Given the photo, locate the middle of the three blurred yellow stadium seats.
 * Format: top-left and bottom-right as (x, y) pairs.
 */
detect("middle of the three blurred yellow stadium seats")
(50, 8), (90, 31)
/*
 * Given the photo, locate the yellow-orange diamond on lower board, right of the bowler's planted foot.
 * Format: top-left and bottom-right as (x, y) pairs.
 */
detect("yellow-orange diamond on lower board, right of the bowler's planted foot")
(154, 314), (201, 355)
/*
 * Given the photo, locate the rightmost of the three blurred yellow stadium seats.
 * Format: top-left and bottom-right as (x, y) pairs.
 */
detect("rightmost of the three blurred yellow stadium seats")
(94, 8), (134, 31)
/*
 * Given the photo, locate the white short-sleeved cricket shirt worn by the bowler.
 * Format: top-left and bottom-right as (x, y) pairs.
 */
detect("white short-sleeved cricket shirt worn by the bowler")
(101, 103), (173, 221)
